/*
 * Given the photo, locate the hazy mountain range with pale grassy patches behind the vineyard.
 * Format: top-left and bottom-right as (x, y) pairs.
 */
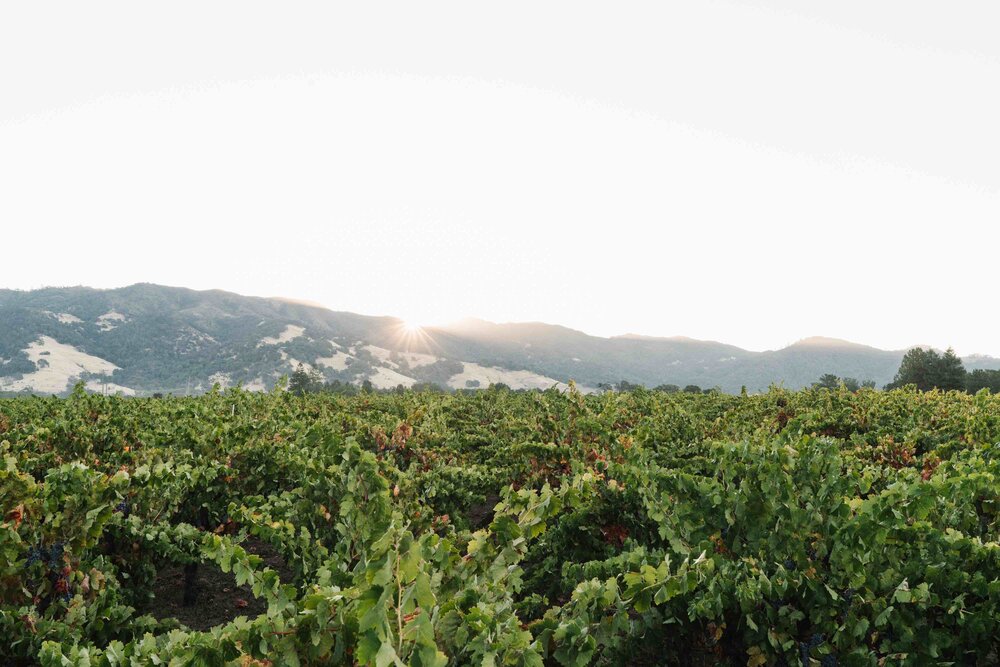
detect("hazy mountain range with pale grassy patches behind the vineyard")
(0, 284), (1000, 395)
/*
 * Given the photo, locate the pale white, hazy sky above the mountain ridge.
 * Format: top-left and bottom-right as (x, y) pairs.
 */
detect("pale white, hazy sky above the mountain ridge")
(0, 0), (1000, 356)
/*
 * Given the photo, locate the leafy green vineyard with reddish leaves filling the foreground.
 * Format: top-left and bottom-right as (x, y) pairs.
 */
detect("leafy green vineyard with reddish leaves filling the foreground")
(0, 388), (1000, 667)
